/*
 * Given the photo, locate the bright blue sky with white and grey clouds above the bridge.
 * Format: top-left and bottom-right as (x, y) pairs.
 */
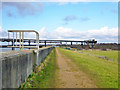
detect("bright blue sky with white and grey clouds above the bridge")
(0, 2), (118, 42)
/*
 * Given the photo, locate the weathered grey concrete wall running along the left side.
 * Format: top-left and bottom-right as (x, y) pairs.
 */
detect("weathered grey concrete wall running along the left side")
(0, 47), (53, 89)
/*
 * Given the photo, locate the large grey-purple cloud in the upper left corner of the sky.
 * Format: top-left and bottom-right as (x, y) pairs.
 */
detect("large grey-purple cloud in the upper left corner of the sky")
(2, 2), (43, 17)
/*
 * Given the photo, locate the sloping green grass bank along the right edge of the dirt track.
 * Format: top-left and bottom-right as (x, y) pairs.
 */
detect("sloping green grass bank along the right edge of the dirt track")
(59, 48), (118, 88)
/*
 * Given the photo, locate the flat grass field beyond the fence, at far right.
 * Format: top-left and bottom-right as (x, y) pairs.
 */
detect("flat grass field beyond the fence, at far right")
(80, 50), (118, 61)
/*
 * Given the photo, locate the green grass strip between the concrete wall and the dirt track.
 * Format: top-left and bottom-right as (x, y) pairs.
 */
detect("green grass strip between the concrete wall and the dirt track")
(20, 49), (56, 88)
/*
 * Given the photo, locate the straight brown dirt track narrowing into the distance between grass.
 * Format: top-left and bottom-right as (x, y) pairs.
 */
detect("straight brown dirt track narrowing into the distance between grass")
(56, 48), (97, 88)
